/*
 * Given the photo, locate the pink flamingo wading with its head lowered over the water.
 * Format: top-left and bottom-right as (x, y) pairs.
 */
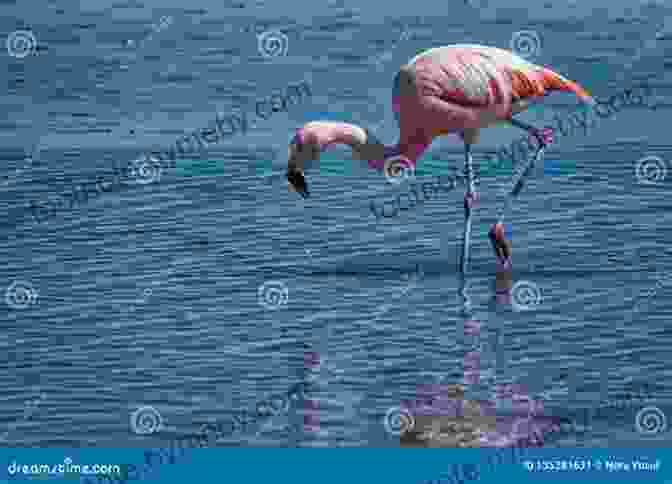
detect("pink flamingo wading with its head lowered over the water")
(286, 44), (595, 276)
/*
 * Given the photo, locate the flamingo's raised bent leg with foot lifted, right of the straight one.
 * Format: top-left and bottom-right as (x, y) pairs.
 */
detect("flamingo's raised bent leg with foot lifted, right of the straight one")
(488, 119), (553, 267)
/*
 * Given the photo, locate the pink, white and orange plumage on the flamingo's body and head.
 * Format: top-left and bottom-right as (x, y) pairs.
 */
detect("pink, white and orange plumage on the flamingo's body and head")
(297, 45), (593, 169)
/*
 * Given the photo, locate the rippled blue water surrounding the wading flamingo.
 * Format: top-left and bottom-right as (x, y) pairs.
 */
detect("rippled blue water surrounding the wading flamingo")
(0, 0), (672, 448)
